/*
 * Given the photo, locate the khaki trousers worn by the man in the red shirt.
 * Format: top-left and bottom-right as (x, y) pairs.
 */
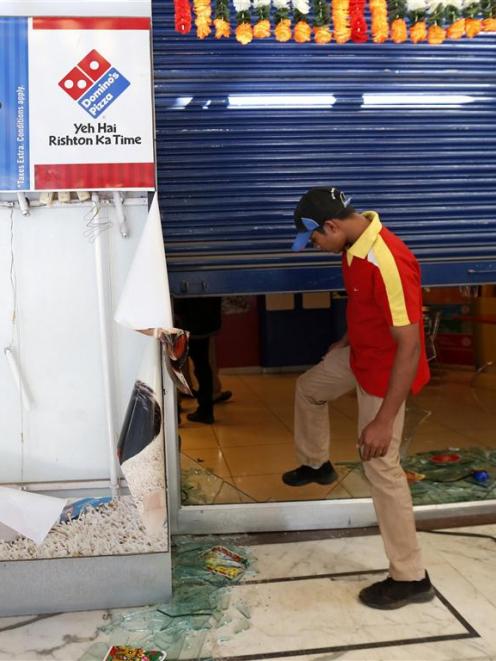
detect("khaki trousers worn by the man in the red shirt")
(295, 347), (425, 581)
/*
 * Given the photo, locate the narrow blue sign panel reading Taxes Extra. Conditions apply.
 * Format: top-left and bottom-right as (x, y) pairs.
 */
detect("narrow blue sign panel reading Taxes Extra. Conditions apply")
(0, 17), (30, 190)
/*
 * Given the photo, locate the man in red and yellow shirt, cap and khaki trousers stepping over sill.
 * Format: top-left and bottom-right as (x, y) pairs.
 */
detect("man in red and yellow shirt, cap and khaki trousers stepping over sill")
(283, 188), (434, 609)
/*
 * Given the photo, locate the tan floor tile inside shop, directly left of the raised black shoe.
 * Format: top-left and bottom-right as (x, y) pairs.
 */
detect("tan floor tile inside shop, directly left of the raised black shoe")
(224, 443), (297, 477)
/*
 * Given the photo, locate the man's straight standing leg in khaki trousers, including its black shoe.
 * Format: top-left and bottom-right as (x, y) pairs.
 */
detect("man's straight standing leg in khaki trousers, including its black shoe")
(357, 386), (433, 608)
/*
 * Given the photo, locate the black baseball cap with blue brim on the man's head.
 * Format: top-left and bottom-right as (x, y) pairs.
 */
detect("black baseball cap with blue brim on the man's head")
(292, 186), (353, 251)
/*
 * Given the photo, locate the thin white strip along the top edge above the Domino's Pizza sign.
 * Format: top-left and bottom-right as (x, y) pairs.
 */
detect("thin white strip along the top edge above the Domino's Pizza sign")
(0, 0), (152, 16)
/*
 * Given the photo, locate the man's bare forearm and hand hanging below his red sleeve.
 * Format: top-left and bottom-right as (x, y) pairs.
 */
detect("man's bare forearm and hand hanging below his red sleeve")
(359, 324), (420, 461)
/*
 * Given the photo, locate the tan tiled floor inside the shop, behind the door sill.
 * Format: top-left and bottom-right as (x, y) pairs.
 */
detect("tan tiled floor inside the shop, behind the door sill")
(180, 368), (496, 502)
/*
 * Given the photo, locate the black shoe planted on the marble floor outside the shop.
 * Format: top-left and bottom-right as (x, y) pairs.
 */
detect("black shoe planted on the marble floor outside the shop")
(358, 572), (435, 610)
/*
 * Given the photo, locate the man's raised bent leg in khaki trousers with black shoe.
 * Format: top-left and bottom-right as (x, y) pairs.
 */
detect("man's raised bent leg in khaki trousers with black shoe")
(282, 347), (356, 487)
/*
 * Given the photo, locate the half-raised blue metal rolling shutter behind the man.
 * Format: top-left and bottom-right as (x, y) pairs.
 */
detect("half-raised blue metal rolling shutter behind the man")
(154, 0), (496, 295)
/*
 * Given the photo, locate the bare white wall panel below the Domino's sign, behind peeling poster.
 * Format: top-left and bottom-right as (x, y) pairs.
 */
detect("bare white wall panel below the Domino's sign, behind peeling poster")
(0, 196), (151, 484)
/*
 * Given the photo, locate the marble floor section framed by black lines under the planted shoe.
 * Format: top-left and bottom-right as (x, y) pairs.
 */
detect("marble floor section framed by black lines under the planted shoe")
(205, 575), (466, 659)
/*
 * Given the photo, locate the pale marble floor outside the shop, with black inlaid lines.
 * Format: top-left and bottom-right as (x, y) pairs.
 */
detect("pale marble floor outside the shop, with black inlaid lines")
(0, 525), (496, 661)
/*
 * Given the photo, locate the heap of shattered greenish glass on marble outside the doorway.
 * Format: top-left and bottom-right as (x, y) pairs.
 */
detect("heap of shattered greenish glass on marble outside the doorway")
(81, 537), (252, 661)
